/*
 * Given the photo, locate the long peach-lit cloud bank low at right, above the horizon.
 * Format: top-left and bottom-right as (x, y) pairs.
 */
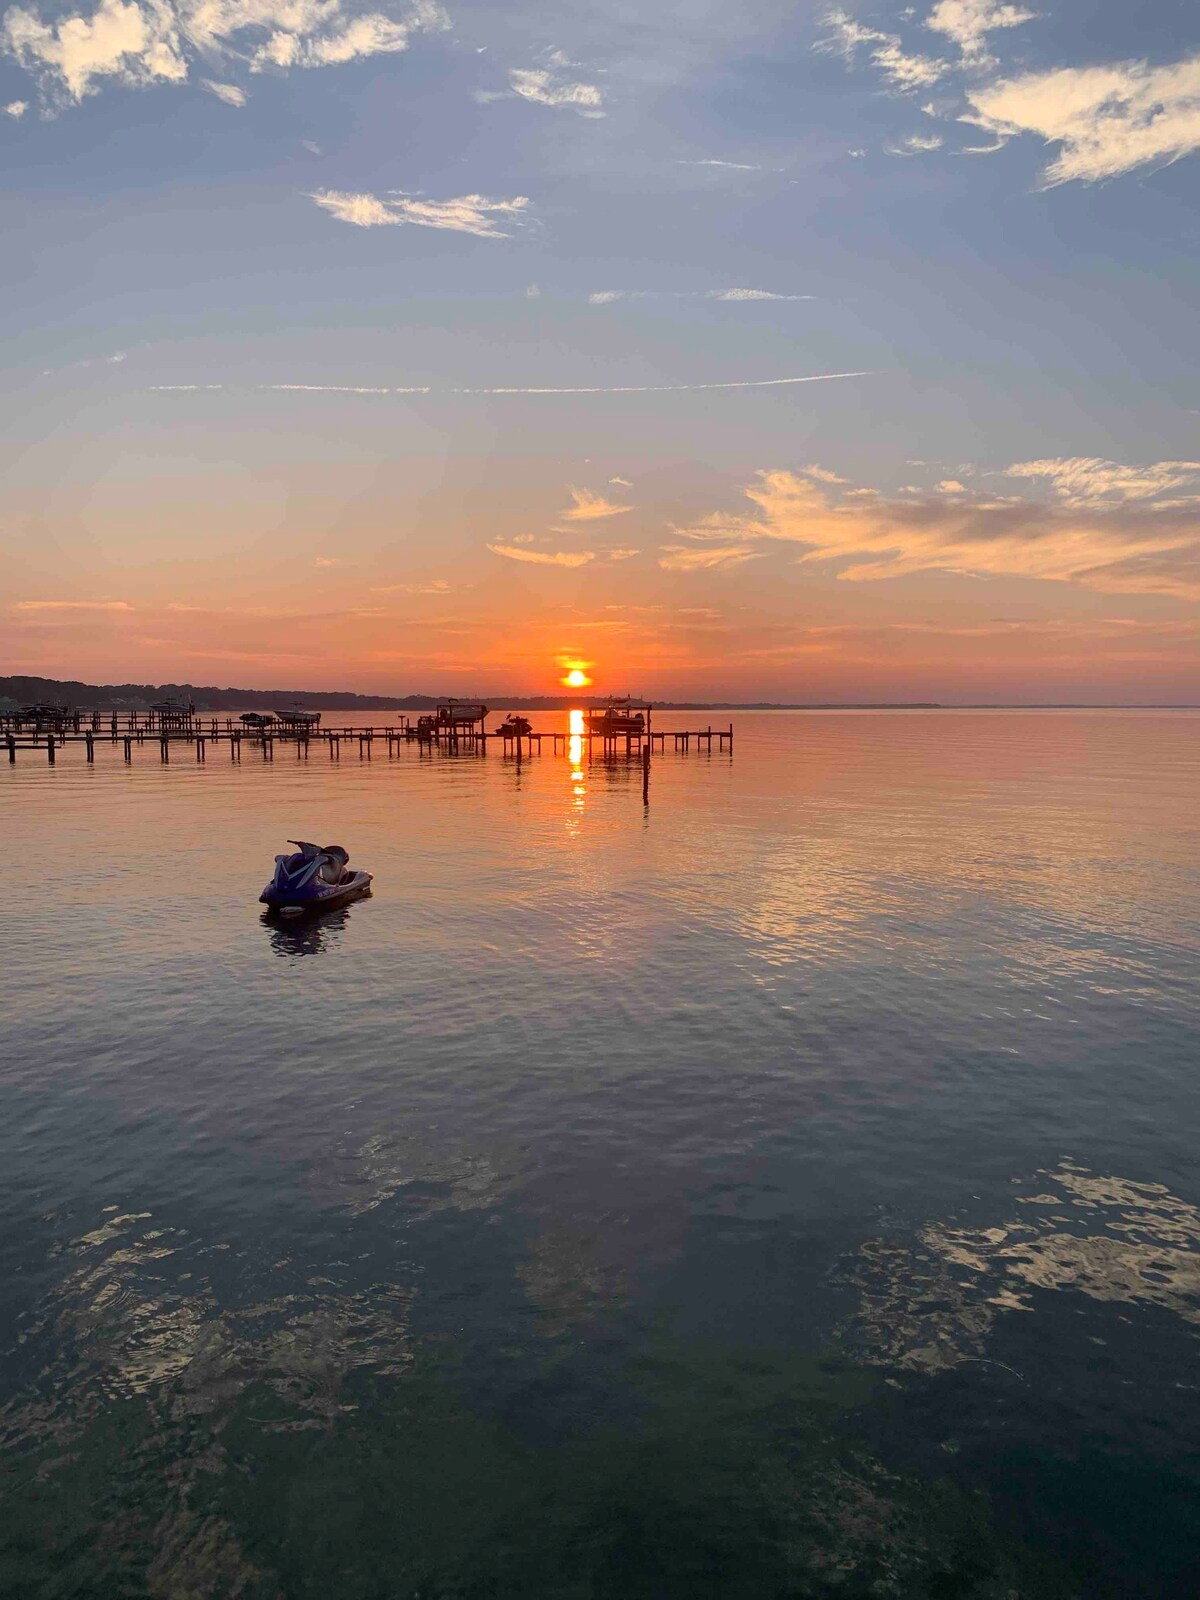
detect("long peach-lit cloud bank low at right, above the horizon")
(678, 472), (1200, 600)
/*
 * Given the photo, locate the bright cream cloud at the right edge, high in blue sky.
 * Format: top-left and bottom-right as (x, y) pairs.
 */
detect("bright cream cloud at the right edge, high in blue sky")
(963, 56), (1200, 189)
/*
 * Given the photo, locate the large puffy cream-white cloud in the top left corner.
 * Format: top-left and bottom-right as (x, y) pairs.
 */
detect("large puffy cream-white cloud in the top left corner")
(0, 0), (448, 104)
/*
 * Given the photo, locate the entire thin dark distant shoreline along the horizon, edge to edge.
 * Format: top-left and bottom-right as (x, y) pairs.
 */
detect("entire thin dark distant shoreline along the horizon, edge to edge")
(0, 677), (1200, 712)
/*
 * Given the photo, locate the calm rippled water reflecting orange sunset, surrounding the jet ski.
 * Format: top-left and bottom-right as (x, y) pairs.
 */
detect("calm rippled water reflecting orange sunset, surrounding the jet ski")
(0, 712), (1200, 1600)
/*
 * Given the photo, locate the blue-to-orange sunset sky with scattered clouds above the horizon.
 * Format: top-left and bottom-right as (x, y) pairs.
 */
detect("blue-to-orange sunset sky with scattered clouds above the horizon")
(0, 0), (1200, 702)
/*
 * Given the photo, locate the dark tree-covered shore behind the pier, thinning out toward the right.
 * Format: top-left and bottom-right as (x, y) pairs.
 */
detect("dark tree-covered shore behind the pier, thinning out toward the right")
(0, 677), (936, 712)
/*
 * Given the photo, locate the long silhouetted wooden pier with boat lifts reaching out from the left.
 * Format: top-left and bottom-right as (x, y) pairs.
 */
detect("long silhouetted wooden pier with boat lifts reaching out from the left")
(0, 701), (733, 766)
